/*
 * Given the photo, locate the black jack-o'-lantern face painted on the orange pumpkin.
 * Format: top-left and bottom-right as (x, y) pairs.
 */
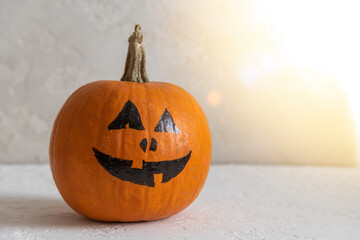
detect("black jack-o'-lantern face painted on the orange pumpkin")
(93, 100), (191, 187)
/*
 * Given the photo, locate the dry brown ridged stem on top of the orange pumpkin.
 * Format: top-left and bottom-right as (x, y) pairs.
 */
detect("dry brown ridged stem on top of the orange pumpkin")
(120, 24), (149, 82)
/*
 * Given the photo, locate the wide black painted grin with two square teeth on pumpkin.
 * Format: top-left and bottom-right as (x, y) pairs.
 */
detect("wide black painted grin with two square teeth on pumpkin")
(93, 148), (191, 187)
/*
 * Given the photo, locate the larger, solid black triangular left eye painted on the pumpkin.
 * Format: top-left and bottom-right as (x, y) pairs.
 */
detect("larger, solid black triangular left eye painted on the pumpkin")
(108, 100), (145, 130)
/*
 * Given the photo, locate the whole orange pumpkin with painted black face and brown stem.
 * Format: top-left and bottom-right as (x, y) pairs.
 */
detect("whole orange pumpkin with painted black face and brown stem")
(50, 25), (211, 222)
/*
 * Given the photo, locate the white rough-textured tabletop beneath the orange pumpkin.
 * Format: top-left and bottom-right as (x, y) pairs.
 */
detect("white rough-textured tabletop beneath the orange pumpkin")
(0, 165), (360, 240)
